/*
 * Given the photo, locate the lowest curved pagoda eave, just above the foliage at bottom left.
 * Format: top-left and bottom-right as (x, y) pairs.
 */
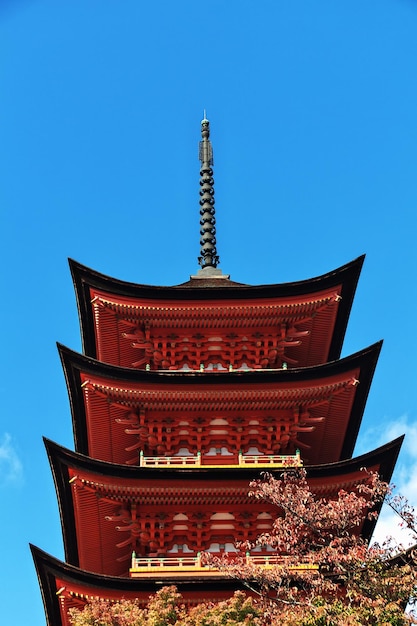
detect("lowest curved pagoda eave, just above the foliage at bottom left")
(30, 545), (239, 626)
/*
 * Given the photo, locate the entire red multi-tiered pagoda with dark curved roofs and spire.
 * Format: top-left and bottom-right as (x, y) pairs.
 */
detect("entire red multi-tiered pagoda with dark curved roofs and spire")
(32, 118), (402, 626)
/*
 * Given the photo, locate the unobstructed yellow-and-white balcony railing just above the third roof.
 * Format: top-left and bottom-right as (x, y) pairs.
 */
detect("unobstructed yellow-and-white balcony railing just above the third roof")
(139, 450), (303, 468)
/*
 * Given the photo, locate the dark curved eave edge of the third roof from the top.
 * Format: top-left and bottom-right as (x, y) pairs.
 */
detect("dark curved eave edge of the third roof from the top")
(45, 437), (403, 565)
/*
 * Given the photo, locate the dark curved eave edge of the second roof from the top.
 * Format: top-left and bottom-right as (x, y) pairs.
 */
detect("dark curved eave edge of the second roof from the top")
(58, 342), (382, 460)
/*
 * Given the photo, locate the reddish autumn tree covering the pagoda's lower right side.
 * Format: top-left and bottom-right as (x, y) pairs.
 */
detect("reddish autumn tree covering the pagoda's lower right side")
(208, 469), (417, 626)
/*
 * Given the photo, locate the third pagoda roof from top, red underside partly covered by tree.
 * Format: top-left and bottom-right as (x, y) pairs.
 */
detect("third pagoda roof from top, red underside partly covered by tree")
(45, 437), (403, 576)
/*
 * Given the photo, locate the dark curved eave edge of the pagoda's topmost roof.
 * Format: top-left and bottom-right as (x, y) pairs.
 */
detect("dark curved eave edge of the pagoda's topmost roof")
(69, 256), (365, 361)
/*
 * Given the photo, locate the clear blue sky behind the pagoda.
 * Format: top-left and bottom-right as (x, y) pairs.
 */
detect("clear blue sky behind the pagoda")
(0, 0), (417, 626)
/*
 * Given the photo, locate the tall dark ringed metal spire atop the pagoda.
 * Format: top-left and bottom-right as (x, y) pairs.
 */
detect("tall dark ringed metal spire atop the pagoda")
(198, 111), (219, 269)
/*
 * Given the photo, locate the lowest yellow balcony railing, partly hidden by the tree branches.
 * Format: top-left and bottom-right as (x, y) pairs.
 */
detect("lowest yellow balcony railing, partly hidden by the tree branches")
(129, 553), (318, 578)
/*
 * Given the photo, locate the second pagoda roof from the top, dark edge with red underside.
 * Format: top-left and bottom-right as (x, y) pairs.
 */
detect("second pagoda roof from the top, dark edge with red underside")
(59, 342), (382, 464)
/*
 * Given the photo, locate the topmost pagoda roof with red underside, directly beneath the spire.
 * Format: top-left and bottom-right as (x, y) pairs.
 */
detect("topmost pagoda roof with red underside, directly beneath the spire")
(70, 256), (364, 367)
